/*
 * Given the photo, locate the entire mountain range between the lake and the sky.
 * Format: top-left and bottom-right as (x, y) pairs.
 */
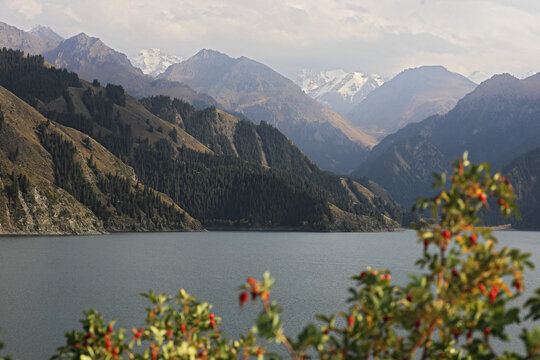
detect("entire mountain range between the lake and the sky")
(0, 20), (540, 233)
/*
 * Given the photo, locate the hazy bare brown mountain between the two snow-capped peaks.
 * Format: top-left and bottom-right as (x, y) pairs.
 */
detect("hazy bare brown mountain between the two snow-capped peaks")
(159, 49), (376, 172)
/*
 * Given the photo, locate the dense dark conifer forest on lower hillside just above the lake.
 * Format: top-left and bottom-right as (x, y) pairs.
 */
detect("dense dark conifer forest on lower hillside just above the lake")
(133, 141), (331, 230)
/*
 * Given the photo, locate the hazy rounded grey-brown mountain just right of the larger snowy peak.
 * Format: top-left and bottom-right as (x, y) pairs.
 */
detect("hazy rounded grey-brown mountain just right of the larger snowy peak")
(347, 66), (476, 139)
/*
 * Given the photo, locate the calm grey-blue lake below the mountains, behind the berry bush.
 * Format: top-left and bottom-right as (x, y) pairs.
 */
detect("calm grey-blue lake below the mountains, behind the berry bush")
(0, 231), (540, 360)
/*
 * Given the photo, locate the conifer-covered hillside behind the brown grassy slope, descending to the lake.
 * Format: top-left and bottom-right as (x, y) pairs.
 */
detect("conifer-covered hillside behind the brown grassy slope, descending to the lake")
(0, 50), (402, 230)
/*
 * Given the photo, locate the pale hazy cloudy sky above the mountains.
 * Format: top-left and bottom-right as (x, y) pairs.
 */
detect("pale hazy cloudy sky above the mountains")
(0, 0), (540, 77)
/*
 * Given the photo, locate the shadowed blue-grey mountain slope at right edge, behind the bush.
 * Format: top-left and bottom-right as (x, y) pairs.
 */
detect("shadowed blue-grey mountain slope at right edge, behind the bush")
(356, 74), (540, 221)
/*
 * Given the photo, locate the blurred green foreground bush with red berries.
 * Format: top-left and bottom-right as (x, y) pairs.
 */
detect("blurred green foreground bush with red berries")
(3, 154), (540, 360)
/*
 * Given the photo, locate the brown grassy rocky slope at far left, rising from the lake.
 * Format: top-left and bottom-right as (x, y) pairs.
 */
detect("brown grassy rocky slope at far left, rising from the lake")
(0, 82), (202, 234)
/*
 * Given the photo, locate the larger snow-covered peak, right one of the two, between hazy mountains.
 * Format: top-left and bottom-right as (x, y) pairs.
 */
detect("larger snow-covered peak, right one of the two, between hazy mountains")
(296, 69), (384, 115)
